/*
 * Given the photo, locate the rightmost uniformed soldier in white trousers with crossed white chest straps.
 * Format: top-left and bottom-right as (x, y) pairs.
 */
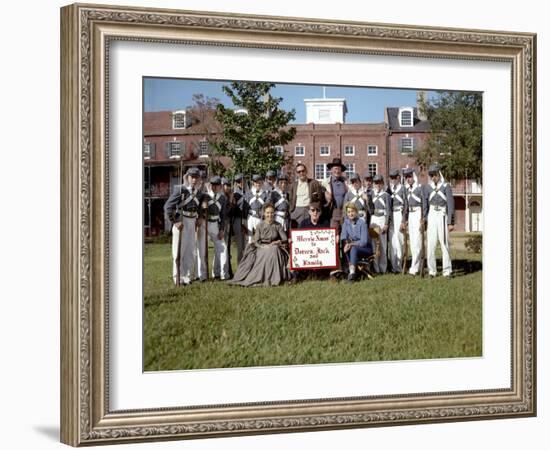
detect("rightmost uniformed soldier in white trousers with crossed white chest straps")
(424, 164), (455, 277)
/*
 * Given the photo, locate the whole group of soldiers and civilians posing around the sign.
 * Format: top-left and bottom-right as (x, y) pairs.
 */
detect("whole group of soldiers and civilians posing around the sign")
(164, 158), (454, 286)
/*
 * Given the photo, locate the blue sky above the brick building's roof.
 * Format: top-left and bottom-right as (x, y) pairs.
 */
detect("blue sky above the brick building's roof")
(143, 78), (432, 123)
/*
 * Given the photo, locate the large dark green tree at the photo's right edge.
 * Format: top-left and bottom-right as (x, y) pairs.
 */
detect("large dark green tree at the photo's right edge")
(415, 92), (482, 181)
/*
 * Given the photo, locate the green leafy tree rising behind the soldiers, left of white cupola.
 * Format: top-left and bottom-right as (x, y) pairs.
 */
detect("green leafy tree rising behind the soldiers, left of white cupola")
(212, 81), (296, 175)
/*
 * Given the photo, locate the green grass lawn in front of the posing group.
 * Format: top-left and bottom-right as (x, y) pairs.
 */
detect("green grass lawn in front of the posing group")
(144, 237), (482, 371)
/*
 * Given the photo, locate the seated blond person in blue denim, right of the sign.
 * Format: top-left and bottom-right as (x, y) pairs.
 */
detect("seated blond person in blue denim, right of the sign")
(340, 202), (373, 283)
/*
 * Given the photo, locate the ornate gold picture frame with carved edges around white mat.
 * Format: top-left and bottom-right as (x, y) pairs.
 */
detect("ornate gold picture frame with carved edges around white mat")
(61, 4), (536, 446)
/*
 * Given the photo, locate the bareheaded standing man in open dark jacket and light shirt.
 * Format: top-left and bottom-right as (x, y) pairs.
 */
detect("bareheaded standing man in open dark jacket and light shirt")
(289, 163), (325, 228)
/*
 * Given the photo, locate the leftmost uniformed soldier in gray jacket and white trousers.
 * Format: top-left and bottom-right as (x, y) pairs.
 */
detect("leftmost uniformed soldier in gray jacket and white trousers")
(164, 168), (202, 285)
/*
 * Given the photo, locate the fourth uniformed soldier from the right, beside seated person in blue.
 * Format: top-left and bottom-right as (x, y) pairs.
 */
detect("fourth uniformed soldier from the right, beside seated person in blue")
(370, 174), (392, 273)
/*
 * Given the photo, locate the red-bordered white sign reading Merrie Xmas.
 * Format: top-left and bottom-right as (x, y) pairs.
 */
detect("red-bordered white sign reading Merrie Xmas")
(290, 228), (340, 270)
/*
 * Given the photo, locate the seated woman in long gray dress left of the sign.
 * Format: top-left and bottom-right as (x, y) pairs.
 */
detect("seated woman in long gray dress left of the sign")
(229, 203), (290, 286)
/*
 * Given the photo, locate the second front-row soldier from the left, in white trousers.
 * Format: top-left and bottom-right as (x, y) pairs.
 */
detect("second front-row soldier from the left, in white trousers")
(197, 176), (229, 281)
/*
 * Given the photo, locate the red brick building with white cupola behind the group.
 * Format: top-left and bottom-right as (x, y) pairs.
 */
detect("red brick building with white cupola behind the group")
(143, 98), (483, 235)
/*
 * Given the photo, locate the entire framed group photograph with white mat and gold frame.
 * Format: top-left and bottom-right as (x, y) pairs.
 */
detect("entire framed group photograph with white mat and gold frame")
(61, 4), (536, 446)
